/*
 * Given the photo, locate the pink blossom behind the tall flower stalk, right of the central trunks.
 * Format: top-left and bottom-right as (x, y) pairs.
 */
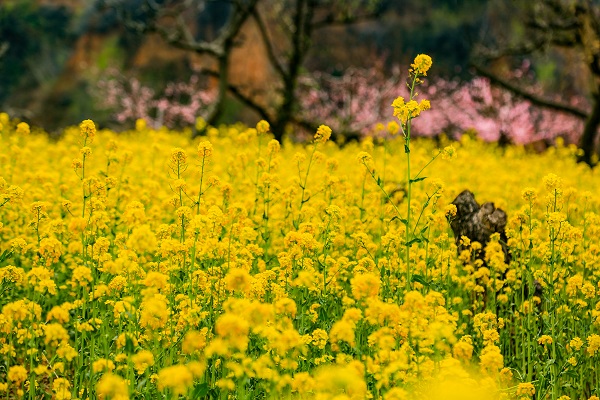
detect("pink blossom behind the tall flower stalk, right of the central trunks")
(299, 62), (585, 144)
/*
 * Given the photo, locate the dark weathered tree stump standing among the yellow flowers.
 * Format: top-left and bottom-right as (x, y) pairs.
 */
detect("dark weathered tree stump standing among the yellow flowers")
(450, 190), (510, 264)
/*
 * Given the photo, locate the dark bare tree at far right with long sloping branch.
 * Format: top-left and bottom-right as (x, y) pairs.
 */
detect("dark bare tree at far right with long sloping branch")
(474, 0), (600, 166)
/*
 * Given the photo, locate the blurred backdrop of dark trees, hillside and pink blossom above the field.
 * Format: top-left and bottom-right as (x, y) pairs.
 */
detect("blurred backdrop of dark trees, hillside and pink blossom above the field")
(0, 0), (600, 165)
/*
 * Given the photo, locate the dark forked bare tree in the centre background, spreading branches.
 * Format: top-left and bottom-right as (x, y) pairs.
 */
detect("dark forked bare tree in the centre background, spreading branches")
(105, 0), (378, 139)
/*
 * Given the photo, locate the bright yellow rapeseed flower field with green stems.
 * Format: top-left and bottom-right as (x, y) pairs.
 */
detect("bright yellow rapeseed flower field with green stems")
(0, 58), (600, 400)
